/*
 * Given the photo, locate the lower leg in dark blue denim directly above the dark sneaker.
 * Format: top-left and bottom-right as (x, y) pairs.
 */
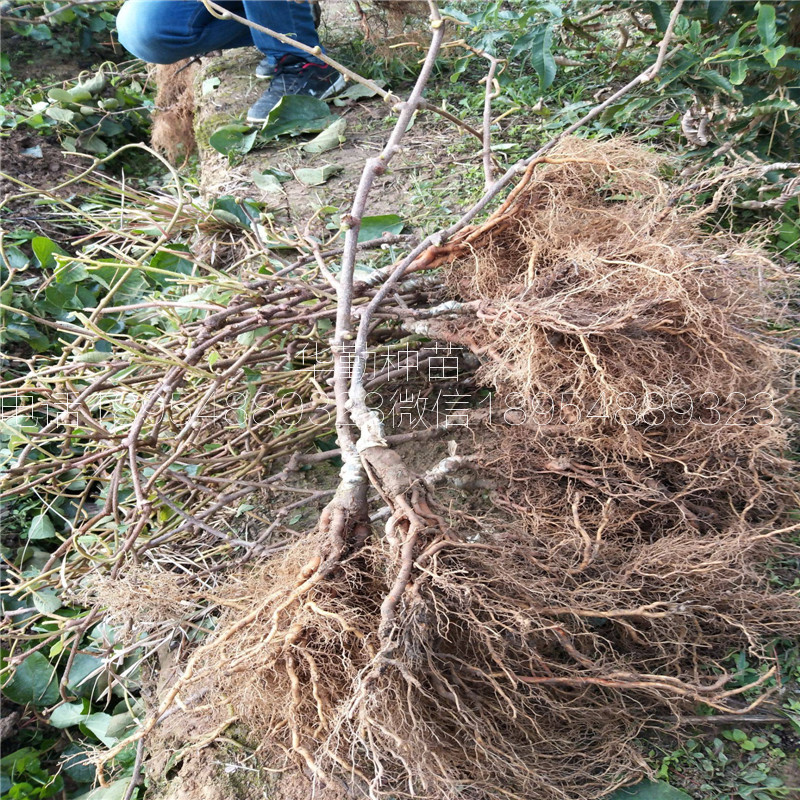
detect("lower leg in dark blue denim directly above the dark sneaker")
(243, 0), (322, 63)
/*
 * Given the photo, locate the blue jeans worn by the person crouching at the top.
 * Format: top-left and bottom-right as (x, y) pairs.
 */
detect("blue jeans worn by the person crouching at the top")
(117, 0), (319, 64)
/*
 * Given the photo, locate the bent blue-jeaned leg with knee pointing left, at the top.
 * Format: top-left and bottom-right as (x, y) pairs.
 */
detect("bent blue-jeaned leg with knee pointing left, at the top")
(117, 0), (252, 64)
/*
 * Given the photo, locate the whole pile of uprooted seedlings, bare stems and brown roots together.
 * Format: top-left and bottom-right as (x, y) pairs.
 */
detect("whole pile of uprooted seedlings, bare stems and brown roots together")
(7, 0), (800, 800)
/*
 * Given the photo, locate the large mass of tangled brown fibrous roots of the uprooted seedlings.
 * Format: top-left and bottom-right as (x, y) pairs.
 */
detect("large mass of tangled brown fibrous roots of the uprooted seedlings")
(108, 140), (800, 800)
